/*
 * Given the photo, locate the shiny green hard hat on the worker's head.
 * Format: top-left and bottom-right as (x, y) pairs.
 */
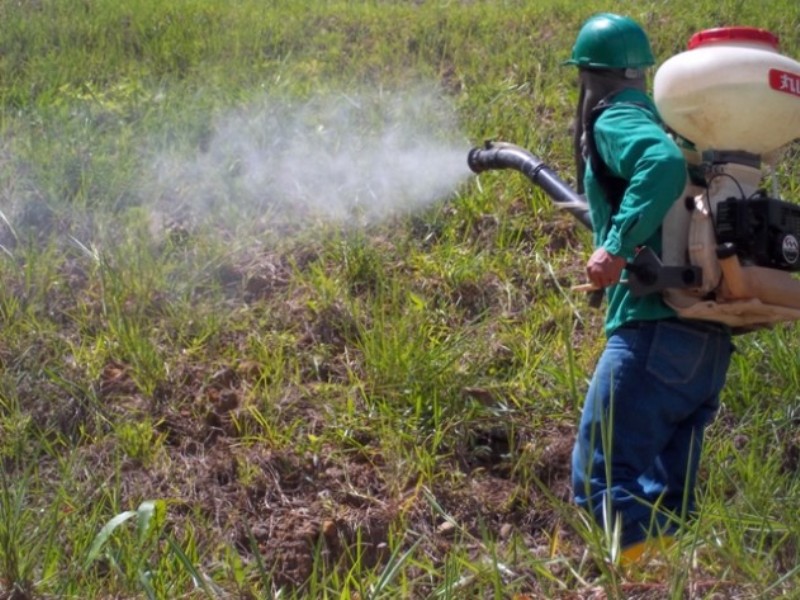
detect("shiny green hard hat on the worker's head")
(565, 13), (655, 69)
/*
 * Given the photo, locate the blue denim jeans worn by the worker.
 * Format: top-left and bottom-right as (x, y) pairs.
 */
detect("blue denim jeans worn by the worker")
(572, 319), (733, 548)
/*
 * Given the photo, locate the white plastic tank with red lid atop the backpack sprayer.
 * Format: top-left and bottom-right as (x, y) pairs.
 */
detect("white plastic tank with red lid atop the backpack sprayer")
(653, 27), (800, 155)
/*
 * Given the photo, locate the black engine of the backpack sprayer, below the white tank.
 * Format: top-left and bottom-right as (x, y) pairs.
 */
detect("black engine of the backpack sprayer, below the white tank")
(715, 191), (800, 272)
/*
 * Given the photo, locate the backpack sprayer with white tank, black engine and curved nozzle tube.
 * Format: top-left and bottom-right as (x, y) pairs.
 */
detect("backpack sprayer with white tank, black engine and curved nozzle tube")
(467, 27), (800, 328)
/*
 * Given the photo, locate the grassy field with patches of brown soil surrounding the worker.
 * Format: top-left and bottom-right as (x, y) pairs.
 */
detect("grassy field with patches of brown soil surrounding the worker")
(0, 0), (800, 600)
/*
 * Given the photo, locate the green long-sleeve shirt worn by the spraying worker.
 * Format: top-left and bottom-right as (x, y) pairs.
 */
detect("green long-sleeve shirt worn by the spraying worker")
(584, 89), (686, 335)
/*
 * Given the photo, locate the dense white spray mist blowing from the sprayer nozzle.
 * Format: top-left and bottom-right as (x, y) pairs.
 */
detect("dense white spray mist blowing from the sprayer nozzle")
(150, 89), (470, 236)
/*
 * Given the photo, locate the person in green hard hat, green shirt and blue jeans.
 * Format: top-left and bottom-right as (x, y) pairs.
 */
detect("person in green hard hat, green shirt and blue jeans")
(567, 13), (733, 563)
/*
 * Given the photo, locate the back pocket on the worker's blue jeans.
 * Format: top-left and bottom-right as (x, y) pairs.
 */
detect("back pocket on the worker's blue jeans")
(647, 321), (708, 385)
